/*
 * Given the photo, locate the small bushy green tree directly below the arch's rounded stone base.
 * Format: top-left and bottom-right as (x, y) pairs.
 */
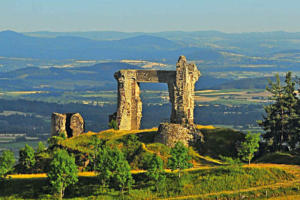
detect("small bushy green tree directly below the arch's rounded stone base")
(168, 142), (193, 177)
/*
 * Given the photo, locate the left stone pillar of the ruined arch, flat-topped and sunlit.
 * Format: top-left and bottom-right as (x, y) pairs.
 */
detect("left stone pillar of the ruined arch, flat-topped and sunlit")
(114, 70), (142, 130)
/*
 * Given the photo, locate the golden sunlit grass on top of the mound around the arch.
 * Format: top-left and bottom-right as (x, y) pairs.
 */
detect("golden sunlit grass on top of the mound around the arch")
(59, 125), (221, 168)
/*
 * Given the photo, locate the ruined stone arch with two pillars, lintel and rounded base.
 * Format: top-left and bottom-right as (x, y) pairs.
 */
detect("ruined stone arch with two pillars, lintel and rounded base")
(110, 56), (201, 146)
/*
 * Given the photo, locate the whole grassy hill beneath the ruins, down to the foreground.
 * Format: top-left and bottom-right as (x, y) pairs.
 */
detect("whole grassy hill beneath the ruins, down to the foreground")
(0, 125), (300, 199)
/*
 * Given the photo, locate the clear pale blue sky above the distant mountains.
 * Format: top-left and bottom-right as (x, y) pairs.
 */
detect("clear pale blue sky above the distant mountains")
(0, 0), (300, 32)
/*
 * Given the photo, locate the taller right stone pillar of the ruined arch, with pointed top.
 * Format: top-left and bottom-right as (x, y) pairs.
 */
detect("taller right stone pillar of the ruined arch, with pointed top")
(169, 56), (201, 125)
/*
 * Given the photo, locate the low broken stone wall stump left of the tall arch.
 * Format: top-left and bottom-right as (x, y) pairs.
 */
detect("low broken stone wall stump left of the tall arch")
(51, 112), (85, 138)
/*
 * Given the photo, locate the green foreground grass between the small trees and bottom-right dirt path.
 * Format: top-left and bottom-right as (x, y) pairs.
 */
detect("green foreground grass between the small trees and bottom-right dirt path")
(0, 167), (294, 199)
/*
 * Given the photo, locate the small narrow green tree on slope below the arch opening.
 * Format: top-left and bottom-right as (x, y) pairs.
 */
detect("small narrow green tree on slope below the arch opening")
(146, 154), (166, 191)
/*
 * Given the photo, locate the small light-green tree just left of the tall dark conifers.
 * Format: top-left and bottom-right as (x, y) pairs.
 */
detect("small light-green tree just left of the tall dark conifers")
(238, 133), (260, 165)
